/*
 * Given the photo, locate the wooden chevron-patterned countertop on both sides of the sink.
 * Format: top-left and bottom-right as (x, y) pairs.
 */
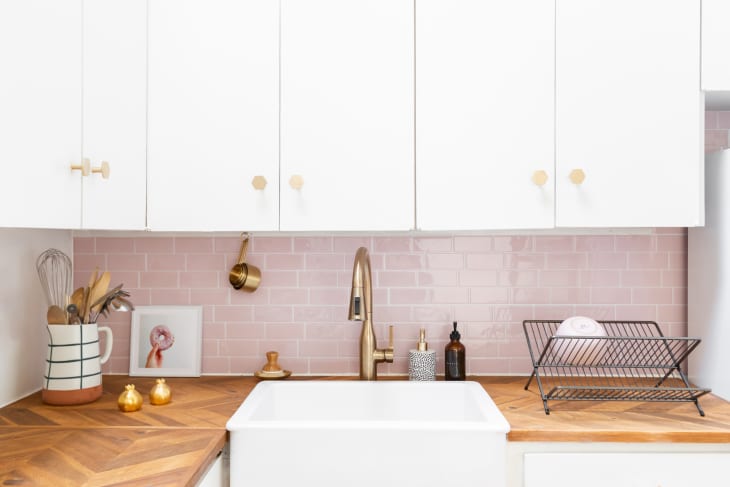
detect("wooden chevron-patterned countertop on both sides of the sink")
(0, 375), (730, 486)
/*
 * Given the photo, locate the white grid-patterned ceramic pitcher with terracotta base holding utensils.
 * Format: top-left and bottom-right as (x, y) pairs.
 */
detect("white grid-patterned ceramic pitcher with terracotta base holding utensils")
(41, 323), (114, 405)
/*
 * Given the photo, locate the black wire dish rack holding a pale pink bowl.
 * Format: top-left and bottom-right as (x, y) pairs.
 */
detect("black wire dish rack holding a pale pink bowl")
(522, 320), (710, 416)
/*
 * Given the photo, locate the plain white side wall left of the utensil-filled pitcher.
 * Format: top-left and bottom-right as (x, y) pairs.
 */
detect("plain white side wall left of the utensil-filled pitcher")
(0, 228), (73, 406)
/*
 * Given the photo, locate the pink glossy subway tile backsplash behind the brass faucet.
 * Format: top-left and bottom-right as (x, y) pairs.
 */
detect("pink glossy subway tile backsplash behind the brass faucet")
(74, 229), (687, 375)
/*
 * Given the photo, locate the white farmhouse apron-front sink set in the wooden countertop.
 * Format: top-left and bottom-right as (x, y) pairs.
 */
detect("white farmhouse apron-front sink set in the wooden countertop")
(227, 381), (509, 487)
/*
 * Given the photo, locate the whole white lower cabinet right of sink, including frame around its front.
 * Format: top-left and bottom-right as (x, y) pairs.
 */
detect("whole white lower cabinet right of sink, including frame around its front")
(508, 442), (730, 487)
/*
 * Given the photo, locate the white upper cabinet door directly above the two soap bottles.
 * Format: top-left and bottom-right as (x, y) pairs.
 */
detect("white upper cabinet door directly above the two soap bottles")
(416, 0), (555, 230)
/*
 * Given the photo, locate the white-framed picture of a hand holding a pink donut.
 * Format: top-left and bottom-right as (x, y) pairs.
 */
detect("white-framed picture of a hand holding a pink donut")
(129, 306), (203, 377)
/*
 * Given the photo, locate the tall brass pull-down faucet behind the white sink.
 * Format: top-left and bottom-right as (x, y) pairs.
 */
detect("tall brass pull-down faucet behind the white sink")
(348, 247), (393, 380)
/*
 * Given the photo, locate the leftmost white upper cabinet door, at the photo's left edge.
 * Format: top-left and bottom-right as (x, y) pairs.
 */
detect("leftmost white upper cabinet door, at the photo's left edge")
(0, 0), (82, 228)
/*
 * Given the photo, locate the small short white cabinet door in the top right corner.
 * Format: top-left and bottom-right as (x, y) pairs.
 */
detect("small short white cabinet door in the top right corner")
(702, 0), (730, 91)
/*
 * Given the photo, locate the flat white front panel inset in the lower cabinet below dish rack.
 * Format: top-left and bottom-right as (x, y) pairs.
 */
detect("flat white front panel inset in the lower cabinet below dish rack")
(524, 452), (730, 487)
